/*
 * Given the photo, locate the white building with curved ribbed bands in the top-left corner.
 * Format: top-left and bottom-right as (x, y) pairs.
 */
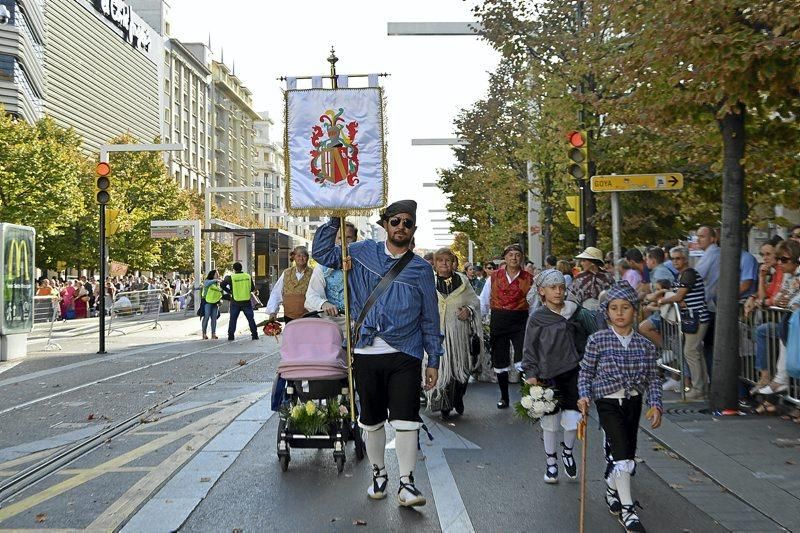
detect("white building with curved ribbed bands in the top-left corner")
(0, 0), (46, 123)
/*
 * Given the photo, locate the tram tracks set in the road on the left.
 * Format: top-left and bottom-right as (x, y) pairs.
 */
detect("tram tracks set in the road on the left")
(0, 342), (278, 507)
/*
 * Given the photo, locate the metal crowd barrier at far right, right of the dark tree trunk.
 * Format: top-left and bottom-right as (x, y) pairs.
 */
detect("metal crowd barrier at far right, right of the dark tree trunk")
(739, 305), (800, 406)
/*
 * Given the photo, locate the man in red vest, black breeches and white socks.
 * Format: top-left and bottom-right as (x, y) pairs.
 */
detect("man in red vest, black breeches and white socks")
(481, 244), (535, 409)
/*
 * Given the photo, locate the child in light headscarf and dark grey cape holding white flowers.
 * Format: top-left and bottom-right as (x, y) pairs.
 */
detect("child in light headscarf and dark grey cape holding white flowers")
(522, 269), (593, 483)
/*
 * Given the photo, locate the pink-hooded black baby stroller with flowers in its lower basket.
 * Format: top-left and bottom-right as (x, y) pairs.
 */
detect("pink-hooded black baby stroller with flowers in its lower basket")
(277, 315), (365, 472)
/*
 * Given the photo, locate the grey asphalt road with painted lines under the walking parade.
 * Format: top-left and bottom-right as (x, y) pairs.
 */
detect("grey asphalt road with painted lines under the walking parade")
(0, 319), (724, 532)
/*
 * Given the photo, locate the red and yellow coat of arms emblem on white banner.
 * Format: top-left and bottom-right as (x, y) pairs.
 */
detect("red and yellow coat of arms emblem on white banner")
(310, 107), (359, 186)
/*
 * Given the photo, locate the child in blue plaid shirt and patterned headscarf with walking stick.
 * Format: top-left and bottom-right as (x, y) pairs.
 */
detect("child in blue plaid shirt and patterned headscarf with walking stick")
(578, 281), (662, 533)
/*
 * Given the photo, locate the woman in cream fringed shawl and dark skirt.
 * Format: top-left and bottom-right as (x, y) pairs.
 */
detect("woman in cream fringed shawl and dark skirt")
(428, 248), (483, 418)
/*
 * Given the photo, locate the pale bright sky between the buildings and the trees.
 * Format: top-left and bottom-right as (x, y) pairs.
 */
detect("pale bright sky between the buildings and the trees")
(168, 0), (499, 248)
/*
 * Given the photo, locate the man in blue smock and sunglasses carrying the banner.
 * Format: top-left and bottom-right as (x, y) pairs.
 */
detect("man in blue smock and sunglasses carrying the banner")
(312, 200), (442, 507)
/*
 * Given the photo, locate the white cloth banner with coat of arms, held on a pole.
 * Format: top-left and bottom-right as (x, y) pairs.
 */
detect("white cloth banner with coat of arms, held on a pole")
(285, 87), (386, 213)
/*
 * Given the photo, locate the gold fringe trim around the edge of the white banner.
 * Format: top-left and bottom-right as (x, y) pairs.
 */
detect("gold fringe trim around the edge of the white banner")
(283, 87), (389, 217)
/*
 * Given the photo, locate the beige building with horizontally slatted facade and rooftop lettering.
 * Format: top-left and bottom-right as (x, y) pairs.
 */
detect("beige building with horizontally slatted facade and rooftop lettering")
(44, 0), (164, 153)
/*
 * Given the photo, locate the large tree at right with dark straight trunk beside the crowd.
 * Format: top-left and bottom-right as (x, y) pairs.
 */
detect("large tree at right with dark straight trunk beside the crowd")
(595, 0), (800, 409)
